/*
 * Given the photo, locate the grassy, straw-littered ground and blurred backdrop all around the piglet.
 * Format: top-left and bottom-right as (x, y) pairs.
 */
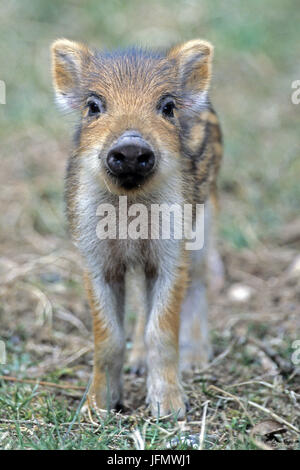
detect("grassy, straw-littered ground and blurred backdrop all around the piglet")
(0, 0), (300, 449)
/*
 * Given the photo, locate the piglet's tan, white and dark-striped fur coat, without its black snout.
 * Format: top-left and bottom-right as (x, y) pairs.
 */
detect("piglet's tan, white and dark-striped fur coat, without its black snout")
(51, 39), (222, 417)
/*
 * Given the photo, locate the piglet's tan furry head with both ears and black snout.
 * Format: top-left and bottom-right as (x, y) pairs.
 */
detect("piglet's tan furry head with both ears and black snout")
(51, 39), (213, 194)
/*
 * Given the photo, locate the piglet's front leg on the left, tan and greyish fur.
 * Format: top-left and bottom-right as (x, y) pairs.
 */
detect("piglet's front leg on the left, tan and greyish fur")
(85, 274), (125, 410)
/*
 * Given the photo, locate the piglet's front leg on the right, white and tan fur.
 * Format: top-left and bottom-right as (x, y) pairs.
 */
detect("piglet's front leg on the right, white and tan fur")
(145, 255), (187, 418)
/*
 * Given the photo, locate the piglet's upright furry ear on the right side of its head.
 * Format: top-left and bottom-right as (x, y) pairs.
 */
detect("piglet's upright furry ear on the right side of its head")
(168, 39), (213, 95)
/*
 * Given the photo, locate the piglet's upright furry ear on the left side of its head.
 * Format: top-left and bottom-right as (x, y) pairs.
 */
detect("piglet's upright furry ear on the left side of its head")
(51, 39), (91, 110)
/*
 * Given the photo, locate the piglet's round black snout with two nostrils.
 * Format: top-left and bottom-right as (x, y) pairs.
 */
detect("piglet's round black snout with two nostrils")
(107, 133), (155, 176)
